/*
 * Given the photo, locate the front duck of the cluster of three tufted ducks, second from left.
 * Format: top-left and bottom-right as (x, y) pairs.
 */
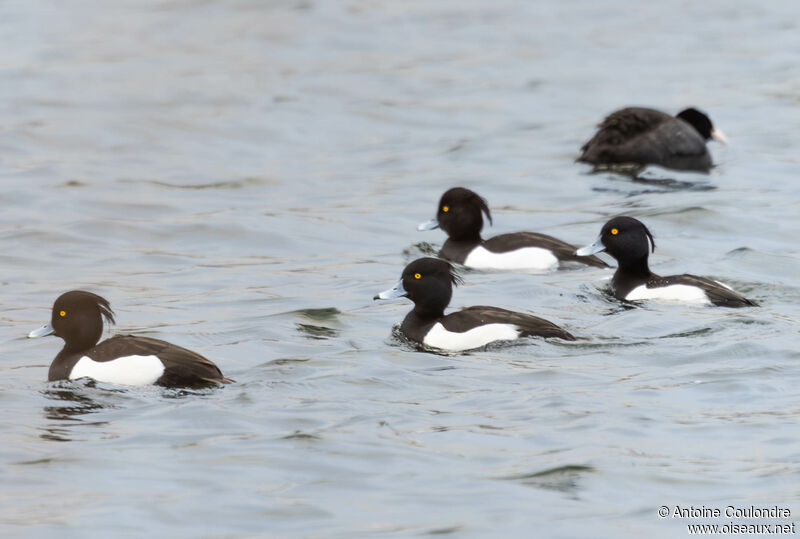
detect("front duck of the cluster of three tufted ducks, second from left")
(373, 258), (575, 352)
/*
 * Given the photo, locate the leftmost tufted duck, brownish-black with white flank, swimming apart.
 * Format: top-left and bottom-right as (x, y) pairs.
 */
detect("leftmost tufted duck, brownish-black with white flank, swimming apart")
(28, 290), (233, 387)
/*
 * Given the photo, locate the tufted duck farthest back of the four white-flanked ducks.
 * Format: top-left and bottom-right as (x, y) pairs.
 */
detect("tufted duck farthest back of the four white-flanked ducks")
(417, 187), (608, 270)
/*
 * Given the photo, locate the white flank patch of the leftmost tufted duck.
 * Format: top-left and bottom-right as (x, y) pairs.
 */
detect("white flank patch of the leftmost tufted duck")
(69, 356), (164, 386)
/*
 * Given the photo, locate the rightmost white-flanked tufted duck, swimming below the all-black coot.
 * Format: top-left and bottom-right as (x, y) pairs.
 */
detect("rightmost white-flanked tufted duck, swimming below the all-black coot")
(577, 216), (757, 307)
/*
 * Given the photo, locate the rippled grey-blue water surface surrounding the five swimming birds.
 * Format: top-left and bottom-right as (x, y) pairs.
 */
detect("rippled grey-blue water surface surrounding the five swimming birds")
(0, 0), (800, 537)
